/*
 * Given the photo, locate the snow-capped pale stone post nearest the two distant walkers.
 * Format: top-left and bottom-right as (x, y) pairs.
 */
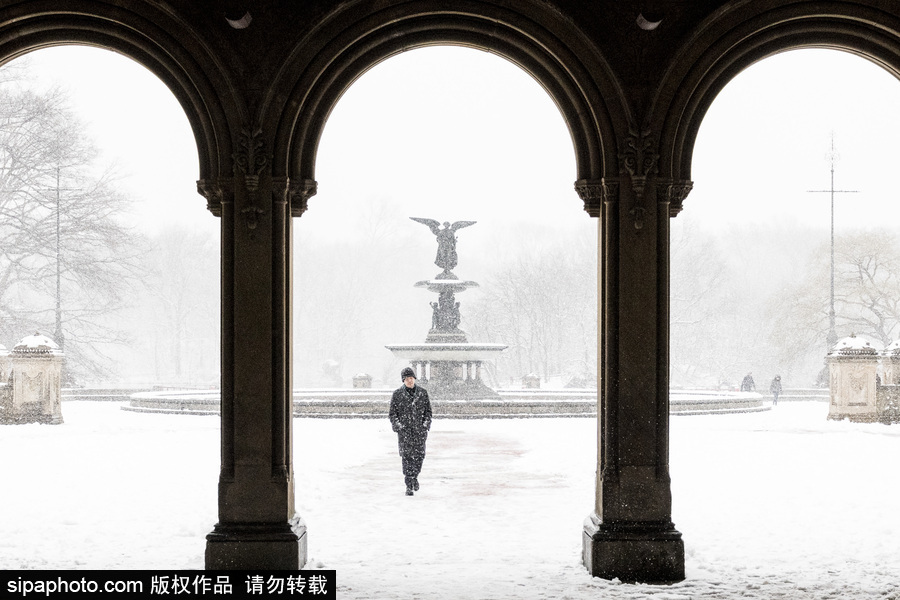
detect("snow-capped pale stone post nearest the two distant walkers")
(825, 335), (878, 422)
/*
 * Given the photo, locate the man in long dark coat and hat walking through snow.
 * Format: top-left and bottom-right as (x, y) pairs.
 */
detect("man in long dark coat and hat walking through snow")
(388, 367), (431, 496)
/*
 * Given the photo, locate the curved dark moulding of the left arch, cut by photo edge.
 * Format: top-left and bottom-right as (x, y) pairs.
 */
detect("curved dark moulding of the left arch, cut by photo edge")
(0, 0), (241, 185)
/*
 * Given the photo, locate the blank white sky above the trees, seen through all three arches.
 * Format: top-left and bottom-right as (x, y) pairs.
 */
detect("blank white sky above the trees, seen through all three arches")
(12, 47), (900, 237)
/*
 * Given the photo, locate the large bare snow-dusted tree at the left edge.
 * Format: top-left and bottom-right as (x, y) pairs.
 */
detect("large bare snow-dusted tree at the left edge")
(0, 68), (140, 382)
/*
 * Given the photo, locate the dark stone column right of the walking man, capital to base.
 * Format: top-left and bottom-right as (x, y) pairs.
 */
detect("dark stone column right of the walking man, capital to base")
(576, 163), (690, 582)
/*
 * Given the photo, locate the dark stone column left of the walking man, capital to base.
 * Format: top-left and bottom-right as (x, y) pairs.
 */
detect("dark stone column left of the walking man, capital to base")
(198, 129), (315, 570)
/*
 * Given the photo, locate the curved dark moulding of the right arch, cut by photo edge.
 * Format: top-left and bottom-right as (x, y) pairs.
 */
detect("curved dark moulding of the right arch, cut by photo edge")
(650, 0), (900, 195)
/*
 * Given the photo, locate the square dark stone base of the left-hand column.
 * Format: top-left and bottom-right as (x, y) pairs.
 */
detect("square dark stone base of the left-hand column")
(206, 523), (307, 571)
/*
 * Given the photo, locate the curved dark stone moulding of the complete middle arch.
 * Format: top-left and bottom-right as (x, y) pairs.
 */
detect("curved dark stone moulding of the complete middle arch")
(266, 0), (628, 195)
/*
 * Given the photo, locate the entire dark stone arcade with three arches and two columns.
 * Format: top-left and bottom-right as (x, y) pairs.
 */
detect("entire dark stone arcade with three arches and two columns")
(0, 0), (900, 582)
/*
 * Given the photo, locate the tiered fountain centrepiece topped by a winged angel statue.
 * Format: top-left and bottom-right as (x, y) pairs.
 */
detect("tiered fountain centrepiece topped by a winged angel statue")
(385, 217), (506, 400)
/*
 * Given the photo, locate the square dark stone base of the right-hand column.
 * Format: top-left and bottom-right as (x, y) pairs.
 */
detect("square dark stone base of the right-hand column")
(582, 515), (684, 583)
